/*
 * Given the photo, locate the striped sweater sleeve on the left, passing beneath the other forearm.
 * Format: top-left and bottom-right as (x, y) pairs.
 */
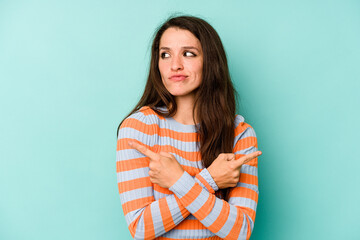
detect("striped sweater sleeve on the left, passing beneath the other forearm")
(116, 109), (218, 239)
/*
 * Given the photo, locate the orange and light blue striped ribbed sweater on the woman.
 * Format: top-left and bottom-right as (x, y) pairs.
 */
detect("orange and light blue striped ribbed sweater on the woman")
(116, 107), (259, 240)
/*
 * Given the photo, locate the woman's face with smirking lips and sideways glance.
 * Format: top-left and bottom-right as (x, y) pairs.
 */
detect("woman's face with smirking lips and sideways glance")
(159, 28), (203, 97)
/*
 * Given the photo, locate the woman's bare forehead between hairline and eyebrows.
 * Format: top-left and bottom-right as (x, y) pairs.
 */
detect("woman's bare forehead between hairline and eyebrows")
(160, 27), (201, 48)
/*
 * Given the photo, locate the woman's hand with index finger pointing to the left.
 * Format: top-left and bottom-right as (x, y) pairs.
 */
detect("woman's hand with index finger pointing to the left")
(128, 141), (184, 188)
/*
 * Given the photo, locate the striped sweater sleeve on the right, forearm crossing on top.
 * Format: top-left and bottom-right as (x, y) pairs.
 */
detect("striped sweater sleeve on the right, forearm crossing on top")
(169, 122), (258, 239)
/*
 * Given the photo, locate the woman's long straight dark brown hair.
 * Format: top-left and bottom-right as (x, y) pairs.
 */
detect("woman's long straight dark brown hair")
(118, 16), (237, 199)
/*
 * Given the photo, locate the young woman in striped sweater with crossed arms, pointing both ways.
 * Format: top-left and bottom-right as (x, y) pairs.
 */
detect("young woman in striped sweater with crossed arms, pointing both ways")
(117, 16), (261, 239)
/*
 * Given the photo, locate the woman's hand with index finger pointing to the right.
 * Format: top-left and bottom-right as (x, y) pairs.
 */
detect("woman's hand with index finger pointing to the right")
(207, 151), (262, 189)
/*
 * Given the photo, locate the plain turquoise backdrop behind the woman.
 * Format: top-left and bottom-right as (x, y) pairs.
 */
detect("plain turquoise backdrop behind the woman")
(0, 0), (360, 240)
